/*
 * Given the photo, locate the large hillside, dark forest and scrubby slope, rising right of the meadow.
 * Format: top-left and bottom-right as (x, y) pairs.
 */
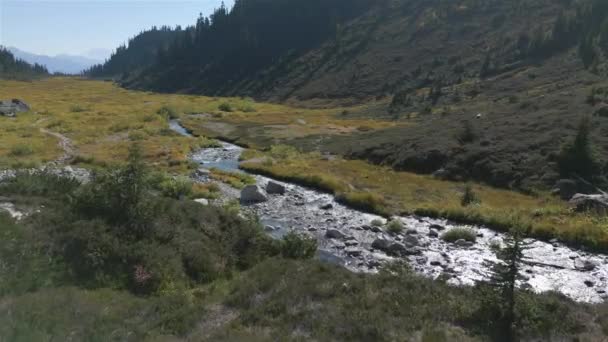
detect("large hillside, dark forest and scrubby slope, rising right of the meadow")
(85, 0), (608, 188)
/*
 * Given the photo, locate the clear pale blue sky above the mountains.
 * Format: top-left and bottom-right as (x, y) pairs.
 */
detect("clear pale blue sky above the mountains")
(0, 0), (233, 55)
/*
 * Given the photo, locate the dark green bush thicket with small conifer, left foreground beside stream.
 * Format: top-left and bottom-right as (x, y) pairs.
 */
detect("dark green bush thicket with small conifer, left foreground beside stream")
(0, 147), (274, 294)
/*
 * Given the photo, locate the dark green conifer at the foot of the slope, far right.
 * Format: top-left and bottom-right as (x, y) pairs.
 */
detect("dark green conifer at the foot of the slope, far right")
(558, 117), (599, 180)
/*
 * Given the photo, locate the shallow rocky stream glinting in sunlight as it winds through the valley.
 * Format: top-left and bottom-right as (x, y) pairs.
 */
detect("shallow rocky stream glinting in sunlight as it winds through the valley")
(170, 121), (608, 303)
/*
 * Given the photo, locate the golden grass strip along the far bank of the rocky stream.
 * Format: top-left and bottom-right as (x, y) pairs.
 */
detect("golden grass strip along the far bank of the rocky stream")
(242, 153), (608, 250)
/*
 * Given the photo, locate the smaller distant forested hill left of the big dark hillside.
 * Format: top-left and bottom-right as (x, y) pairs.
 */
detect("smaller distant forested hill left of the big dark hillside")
(84, 26), (183, 77)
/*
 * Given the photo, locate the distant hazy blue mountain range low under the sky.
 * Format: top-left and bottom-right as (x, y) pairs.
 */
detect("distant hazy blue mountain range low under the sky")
(8, 47), (103, 74)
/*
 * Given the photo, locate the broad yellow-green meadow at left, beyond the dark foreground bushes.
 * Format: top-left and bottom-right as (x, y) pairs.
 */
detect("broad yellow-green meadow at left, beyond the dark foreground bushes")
(0, 78), (380, 172)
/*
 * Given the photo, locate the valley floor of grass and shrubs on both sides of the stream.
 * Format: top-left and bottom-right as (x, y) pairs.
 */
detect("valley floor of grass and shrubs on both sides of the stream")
(0, 78), (608, 341)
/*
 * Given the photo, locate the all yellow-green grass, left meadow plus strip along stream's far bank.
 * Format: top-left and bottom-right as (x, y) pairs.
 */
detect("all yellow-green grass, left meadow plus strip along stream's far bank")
(0, 78), (608, 250)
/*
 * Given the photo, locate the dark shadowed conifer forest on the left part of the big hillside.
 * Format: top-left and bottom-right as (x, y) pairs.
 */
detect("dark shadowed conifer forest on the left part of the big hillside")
(112, 0), (370, 93)
